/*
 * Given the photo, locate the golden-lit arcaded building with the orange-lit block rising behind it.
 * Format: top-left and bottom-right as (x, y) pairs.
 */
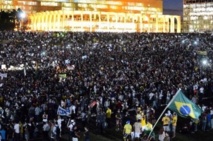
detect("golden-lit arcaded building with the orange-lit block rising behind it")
(0, 0), (181, 33)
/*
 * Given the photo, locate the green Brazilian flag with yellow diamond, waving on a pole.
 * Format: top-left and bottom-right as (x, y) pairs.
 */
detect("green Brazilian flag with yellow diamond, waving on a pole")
(168, 90), (202, 119)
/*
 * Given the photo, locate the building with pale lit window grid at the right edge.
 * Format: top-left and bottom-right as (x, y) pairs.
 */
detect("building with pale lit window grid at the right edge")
(183, 0), (213, 32)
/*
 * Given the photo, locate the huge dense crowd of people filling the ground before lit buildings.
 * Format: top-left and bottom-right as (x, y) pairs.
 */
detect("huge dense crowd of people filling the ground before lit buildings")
(0, 31), (213, 141)
